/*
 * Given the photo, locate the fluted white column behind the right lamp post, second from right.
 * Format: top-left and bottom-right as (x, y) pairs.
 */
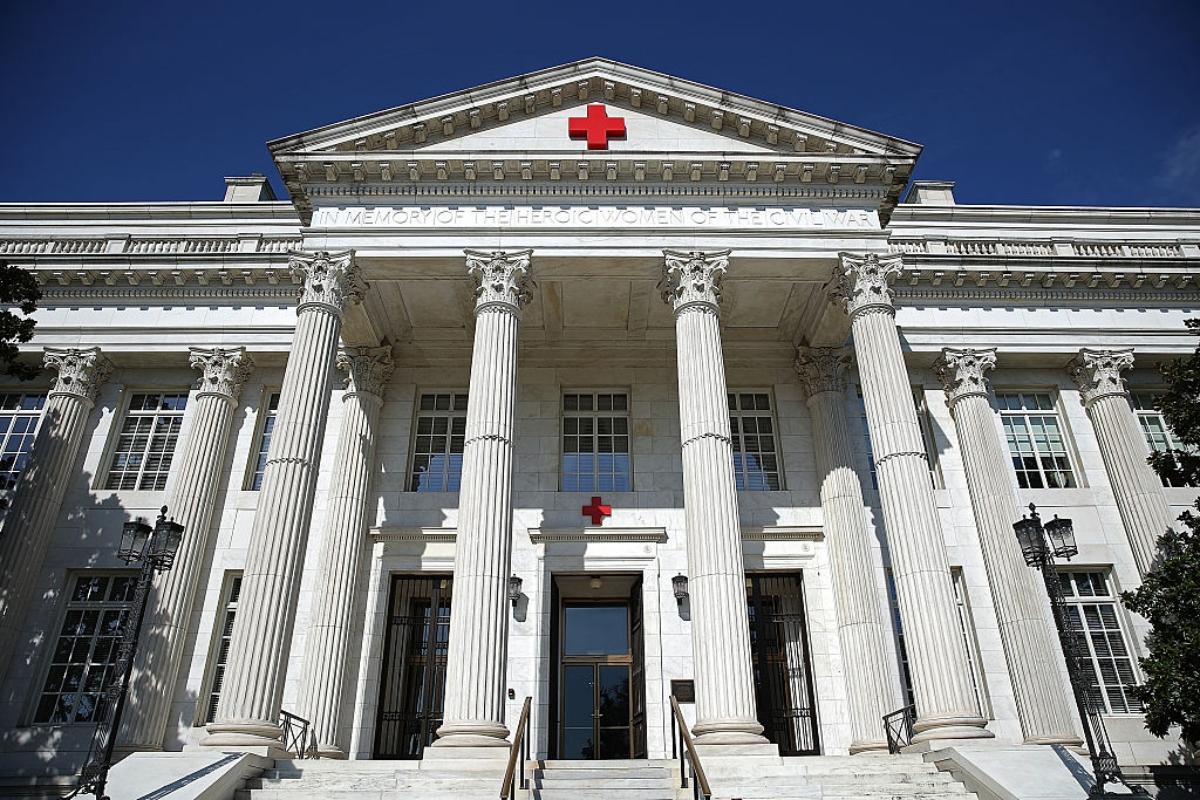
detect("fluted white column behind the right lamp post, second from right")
(934, 348), (1080, 745)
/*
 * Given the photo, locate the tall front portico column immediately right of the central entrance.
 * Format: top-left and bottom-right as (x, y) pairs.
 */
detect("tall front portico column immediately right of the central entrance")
(659, 251), (766, 745)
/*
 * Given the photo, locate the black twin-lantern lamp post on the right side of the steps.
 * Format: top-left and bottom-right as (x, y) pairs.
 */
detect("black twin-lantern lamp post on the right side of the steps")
(1013, 503), (1146, 798)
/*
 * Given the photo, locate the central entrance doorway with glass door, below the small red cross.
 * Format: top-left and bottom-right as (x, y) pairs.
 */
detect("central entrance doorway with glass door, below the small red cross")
(550, 575), (646, 759)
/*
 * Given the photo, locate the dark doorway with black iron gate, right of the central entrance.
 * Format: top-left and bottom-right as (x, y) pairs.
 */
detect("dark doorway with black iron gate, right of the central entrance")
(746, 573), (821, 756)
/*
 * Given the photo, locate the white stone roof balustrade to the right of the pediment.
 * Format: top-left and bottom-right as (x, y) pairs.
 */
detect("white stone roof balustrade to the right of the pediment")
(888, 237), (1200, 259)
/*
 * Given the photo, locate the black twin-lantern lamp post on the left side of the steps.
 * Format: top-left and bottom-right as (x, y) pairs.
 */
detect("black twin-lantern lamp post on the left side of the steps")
(74, 506), (184, 800)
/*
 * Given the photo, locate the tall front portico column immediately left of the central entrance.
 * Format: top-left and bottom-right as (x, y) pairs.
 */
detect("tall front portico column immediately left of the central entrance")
(433, 249), (533, 747)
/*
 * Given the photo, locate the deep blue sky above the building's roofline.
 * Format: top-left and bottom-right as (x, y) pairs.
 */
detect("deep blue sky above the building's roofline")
(0, 0), (1200, 206)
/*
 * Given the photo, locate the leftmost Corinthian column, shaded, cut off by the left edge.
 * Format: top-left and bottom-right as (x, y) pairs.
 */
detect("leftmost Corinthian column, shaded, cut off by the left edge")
(0, 348), (113, 681)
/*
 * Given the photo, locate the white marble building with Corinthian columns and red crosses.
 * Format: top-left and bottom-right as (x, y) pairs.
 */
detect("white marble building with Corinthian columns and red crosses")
(0, 59), (1200, 790)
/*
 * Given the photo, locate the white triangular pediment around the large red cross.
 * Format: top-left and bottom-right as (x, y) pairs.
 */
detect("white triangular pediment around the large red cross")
(269, 58), (920, 221)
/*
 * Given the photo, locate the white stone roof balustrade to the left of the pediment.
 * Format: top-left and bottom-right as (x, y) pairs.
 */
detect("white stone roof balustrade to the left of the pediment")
(0, 235), (300, 255)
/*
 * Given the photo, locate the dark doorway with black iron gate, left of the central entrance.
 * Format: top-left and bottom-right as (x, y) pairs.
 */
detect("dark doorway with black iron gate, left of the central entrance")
(374, 575), (452, 759)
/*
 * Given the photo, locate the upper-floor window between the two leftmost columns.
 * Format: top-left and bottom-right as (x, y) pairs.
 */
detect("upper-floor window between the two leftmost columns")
(104, 392), (187, 492)
